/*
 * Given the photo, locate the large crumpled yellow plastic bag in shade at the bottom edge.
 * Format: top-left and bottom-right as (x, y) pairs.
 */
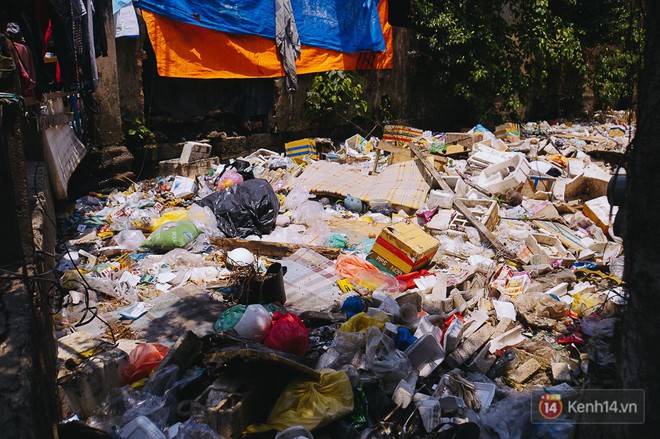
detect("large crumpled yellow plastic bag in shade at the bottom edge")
(245, 369), (353, 434)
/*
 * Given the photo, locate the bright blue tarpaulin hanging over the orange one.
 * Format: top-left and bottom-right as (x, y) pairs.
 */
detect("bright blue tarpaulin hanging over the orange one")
(134, 0), (385, 53)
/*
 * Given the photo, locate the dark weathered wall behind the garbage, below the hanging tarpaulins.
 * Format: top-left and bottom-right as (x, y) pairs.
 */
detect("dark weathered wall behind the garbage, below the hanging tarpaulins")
(137, 27), (439, 151)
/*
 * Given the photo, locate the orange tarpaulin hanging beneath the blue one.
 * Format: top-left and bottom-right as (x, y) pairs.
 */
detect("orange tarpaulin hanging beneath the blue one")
(142, 0), (393, 79)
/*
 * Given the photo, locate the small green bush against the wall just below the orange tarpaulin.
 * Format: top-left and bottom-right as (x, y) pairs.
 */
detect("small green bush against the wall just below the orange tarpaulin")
(305, 70), (369, 120)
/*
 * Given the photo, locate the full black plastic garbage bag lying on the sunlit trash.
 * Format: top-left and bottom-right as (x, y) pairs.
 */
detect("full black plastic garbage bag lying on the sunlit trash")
(197, 178), (280, 238)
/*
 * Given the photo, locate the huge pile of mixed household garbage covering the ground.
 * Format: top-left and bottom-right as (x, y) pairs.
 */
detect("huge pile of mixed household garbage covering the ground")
(56, 114), (634, 438)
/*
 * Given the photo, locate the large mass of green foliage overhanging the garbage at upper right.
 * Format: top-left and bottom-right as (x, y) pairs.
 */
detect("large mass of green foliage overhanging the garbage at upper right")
(414, 0), (641, 119)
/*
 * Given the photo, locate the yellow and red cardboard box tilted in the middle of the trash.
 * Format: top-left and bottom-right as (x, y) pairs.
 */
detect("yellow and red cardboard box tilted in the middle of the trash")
(367, 222), (440, 276)
